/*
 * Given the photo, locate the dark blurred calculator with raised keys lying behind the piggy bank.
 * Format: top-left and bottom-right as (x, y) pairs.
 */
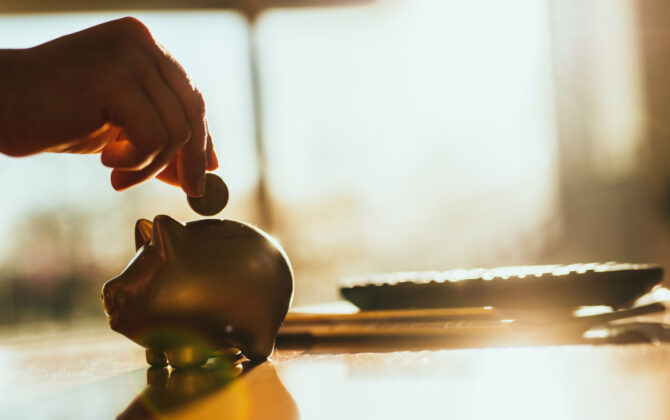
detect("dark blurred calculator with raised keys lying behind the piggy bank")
(340, 262), (663, 310)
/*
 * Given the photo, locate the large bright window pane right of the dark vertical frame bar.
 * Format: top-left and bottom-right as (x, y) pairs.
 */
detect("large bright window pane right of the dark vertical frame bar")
(259, 0), (557, 303)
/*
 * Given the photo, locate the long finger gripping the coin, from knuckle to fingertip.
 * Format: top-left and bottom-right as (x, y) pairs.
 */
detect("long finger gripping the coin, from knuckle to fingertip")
(158, 50), (208, 197)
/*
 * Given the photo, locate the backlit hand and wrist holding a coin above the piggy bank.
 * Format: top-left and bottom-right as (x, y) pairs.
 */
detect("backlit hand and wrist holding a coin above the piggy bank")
(0, 18), (218, 196)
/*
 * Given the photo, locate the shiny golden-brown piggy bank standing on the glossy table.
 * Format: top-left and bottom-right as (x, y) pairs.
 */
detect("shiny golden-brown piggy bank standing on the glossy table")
(102, 215), (293, 368)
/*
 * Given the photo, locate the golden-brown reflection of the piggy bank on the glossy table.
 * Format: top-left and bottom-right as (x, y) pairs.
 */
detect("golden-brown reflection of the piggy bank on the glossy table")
(117, 359), (299, 420)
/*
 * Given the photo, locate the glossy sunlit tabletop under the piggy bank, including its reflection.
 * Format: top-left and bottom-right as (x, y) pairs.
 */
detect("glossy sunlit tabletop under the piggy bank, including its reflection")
(0, 315), (670, 419)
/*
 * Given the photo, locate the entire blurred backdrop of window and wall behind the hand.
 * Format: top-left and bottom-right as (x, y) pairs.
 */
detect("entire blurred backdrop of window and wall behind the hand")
(0, 0), (670, 325)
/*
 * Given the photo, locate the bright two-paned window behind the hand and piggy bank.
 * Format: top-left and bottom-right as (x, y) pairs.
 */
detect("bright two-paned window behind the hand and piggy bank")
(0, 0), (558, 322)
